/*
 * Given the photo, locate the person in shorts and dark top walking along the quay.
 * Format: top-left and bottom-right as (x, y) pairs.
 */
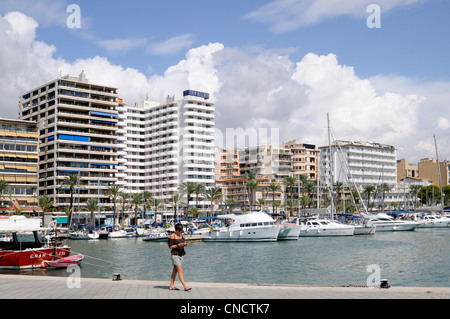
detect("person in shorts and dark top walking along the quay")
(169, 224), (192, 291)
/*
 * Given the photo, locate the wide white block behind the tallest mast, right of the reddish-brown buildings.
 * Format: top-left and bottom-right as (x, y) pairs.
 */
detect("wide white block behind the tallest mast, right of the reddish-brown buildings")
(319, 141), (397, 188)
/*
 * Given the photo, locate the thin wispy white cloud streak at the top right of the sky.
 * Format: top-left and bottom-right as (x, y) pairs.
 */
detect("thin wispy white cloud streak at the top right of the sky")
(244, 0), (427, 32)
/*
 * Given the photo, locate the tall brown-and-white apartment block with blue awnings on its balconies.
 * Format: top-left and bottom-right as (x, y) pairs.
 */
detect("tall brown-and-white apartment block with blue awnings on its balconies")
(19, 72), (118, 220)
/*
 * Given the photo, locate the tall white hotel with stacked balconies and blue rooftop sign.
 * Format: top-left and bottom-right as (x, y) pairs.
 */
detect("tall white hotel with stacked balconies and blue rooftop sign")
(118, 90), (215, 208)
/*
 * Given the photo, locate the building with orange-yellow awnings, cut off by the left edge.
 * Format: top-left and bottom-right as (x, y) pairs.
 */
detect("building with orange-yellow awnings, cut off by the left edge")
(0, 119), (39, 214)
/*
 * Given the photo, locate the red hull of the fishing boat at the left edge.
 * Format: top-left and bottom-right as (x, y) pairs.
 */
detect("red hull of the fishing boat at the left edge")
(0, 246), (70, 270)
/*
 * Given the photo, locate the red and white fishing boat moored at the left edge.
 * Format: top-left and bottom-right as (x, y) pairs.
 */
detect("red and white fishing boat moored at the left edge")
(0, 216), (76, 270)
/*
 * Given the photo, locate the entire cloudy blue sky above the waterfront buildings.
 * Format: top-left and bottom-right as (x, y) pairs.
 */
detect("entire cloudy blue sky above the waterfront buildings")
(0, 0), (450, 163)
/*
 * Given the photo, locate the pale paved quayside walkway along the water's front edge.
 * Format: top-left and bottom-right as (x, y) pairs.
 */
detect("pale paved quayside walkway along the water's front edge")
(0, 275), (450, 301)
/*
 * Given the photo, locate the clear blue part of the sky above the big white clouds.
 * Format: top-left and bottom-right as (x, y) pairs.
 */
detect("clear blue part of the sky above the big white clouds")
(27, 0), (450, 80)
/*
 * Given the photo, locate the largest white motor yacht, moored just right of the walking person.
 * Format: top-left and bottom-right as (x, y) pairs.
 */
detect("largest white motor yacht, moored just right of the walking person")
(204, 212), (280, 242)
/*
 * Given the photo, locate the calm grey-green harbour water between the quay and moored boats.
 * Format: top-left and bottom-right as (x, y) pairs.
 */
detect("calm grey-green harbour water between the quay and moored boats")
(4, 228), (450, 287)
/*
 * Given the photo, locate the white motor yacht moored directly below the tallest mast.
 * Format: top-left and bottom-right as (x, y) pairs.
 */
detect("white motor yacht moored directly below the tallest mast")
(299, 219), (355, 237)
